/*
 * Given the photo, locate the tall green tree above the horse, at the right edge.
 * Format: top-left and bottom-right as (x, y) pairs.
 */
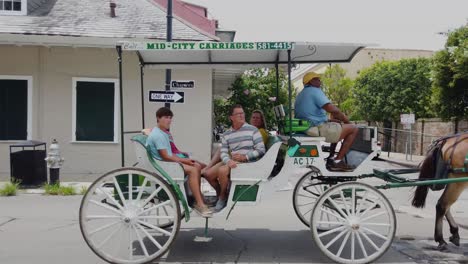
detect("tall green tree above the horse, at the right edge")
(432, 26), (468, 119)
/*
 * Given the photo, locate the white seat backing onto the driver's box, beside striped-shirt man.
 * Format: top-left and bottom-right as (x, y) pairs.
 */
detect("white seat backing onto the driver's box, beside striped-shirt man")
(231, 141), (282, 182)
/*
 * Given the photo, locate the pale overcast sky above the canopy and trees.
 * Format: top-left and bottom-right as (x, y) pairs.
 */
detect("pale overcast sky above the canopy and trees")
(184, 0), (468, 50)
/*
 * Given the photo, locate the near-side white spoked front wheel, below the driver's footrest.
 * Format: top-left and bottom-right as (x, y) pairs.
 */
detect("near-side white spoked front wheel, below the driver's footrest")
(311, 182), (396, 263)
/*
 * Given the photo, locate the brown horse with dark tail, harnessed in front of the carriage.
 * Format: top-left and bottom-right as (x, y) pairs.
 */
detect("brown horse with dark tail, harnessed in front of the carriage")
(412, 132), (468, 251)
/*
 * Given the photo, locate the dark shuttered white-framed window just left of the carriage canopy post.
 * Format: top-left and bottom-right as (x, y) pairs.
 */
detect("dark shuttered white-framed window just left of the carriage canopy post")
(72, 78), (119, 143)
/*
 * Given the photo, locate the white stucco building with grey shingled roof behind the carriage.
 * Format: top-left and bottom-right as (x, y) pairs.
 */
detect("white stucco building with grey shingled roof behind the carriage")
(0, 0), (232, 181)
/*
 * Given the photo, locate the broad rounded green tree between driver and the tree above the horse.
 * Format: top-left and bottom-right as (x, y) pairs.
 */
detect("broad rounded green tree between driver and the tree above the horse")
(353, 58), (433, 121)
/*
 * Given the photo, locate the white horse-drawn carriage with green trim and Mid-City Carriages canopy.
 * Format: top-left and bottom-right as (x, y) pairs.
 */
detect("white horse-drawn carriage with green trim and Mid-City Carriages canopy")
(80, 43), (416, 264)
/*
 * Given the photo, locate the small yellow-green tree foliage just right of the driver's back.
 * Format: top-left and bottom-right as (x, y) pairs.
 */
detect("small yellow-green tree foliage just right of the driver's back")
(321, 64), (359, 119)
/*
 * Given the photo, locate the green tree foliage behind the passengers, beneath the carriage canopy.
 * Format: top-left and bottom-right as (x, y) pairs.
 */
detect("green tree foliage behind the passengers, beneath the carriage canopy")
(214, 69), (295, 129)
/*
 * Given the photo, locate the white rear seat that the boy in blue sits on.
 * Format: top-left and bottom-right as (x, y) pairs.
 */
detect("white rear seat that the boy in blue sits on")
(131, 135), (185, 181)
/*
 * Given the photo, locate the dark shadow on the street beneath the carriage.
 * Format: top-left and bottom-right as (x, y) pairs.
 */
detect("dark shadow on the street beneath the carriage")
(155, 228), (410, 263)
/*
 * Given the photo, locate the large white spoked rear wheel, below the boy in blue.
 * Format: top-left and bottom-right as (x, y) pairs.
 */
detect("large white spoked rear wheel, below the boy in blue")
(80, 168), (181, 264)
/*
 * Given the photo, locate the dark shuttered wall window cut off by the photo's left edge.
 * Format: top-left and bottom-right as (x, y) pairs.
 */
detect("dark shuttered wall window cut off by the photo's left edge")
(0, 75), (32, 140)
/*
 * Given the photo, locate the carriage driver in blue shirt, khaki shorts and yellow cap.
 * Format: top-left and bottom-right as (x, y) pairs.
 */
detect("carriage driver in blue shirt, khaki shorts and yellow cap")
(294, 72), (358, 171)
